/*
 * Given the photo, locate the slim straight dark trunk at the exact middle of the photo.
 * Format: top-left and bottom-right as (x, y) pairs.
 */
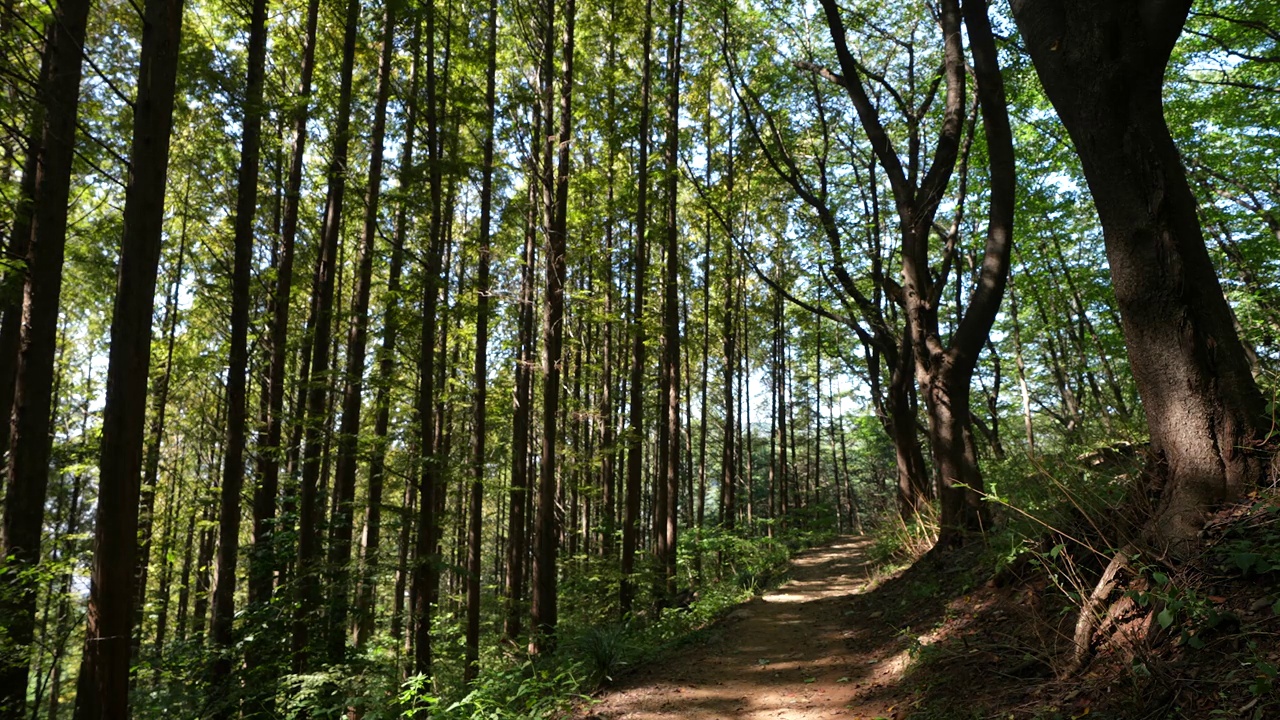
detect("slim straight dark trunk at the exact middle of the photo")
(618, 0), (653, 616)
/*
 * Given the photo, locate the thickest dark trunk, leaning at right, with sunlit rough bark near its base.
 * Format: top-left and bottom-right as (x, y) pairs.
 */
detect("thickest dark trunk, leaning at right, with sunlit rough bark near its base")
(1012, 0), (1267, 551)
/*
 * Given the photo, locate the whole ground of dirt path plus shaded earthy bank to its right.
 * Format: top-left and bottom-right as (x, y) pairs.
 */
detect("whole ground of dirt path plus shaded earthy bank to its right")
(579, 520), (1280, 720)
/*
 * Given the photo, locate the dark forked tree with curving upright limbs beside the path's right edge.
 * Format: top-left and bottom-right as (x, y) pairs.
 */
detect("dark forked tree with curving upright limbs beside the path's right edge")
(822, 0), (1015, 547)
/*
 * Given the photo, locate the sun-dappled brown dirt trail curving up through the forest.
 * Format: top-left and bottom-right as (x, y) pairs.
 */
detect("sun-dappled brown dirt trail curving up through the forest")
(588, 538), (906, 720)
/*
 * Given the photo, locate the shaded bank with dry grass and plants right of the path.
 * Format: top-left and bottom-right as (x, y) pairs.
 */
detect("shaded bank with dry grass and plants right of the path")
(855, 443), (1280, 720)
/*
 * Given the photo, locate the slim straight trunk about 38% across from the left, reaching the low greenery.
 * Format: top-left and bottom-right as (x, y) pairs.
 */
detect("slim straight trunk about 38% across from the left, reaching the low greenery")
(463, 0), (498, 683)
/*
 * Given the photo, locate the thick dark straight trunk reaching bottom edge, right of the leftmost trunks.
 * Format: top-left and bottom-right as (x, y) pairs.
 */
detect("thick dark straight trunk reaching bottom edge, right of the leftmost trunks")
(73, 0), (183, 719)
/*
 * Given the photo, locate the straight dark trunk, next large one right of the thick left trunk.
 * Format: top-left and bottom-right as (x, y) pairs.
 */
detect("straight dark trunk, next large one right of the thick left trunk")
(211, 0), (266, 702)
